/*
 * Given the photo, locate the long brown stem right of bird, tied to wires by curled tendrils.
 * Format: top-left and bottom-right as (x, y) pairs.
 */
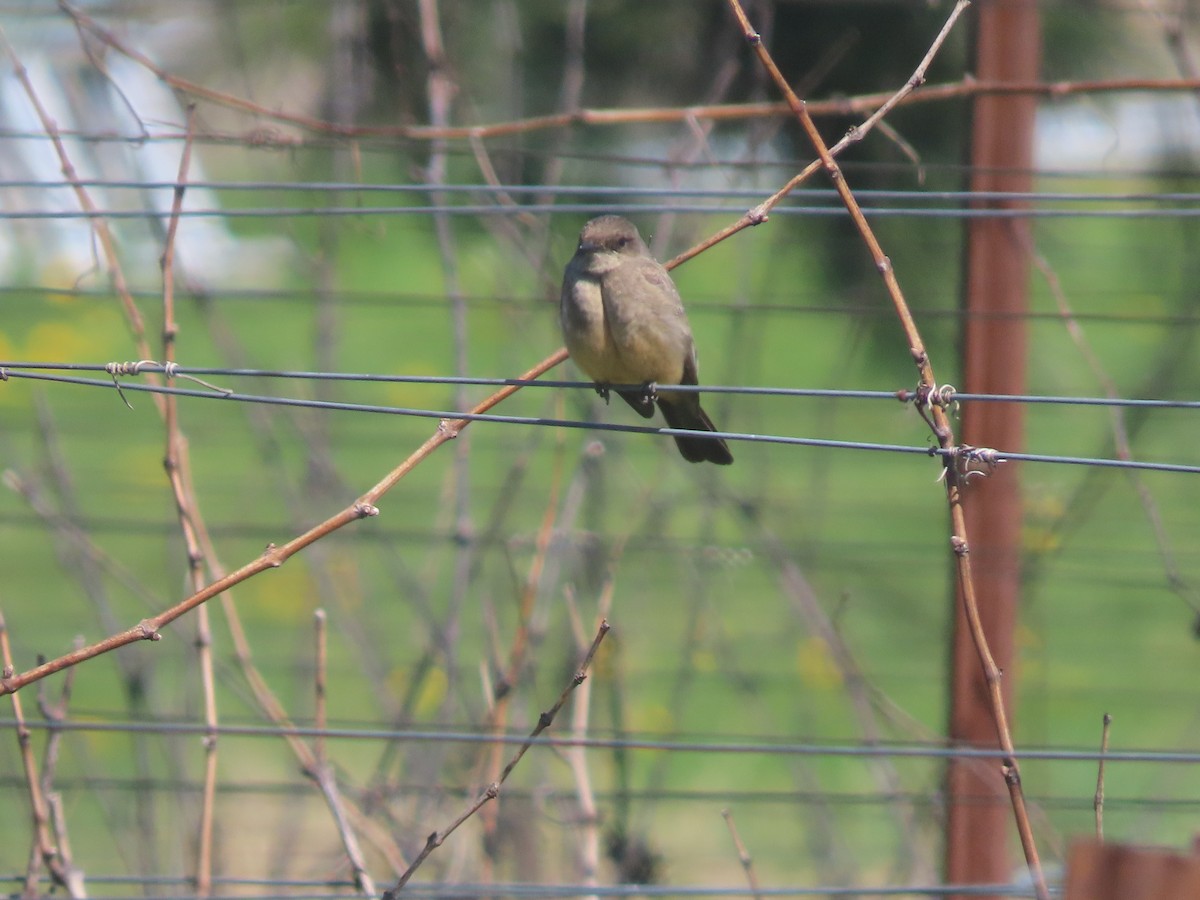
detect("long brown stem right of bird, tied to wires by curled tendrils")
(728, 0), (1050, 900)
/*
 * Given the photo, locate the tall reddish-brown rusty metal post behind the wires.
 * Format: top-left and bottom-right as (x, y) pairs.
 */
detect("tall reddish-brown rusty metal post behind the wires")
(946, 0), (1042, 897)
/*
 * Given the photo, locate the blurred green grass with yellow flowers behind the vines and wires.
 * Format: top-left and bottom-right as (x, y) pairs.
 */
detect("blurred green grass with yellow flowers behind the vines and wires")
(0, 164), (1200, 897)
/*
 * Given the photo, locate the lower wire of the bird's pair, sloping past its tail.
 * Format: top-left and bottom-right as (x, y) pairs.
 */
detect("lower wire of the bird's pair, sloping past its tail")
(7, 371), (1200, 474)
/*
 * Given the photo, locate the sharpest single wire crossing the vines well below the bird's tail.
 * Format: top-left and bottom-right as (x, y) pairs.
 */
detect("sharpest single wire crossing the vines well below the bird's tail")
(0, 719), (1200, 766)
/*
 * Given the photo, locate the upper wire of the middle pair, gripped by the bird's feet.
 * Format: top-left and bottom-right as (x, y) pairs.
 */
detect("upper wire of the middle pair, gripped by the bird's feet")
(0, 361), (1200, 409)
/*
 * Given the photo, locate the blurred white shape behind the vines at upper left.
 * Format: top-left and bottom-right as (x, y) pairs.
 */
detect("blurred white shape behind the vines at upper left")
(0, 14), (294, 289)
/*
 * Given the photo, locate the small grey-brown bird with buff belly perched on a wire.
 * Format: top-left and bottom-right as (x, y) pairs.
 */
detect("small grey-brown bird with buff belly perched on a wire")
(559, 216), (733, 466)
